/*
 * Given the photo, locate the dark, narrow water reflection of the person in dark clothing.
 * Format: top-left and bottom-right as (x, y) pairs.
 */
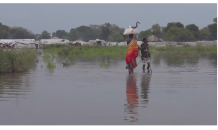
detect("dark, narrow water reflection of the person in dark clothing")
(141, 73), (151, 107)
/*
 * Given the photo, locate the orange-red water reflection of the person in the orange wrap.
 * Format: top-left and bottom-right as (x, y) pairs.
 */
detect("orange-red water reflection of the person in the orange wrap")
(125, 75), (138, 122)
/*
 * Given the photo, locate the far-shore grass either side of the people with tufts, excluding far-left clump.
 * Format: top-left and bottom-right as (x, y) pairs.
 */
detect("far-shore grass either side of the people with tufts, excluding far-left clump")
(42, 44), (218, 68)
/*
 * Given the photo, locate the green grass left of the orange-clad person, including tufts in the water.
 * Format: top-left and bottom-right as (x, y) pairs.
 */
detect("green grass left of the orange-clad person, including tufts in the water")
(42, 44), (126, 67)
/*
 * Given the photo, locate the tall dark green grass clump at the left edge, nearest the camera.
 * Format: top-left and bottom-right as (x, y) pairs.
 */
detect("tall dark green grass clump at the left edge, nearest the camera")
(0, 48), (37, 73)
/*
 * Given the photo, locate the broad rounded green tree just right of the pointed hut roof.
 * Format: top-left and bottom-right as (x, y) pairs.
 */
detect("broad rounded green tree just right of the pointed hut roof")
(164, 27), (195, 42)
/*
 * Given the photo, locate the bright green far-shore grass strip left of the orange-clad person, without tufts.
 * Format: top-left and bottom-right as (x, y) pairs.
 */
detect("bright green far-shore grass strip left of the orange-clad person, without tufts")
(42, 44), (126, 58)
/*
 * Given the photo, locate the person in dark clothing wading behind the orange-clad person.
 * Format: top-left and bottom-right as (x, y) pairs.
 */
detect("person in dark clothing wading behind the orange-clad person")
(138, 38), (151, 71)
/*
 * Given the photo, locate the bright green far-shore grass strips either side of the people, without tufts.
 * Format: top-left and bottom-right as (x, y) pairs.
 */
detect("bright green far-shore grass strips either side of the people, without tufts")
(43, 44), (218, 58)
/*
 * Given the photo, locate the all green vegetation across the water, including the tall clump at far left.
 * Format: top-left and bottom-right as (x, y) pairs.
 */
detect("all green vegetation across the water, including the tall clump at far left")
(0, 44), (218, 73)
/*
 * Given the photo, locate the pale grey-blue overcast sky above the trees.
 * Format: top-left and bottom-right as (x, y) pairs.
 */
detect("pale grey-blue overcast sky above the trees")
(0, 3), (218, 34)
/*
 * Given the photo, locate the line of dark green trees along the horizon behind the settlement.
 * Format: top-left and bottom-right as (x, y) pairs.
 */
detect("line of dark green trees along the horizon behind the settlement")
(0, 17), (218, 42)
